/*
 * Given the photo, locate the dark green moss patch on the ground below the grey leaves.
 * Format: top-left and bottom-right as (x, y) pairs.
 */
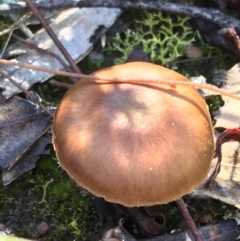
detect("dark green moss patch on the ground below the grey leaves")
(0, 157), (97, 241)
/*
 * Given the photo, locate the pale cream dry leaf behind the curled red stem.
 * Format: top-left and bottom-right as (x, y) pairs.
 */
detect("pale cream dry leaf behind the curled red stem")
(205, 64), (240, 208)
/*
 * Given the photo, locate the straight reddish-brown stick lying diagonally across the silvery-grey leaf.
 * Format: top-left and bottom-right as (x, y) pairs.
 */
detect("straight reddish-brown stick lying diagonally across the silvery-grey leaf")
(25, 0), (81, 74)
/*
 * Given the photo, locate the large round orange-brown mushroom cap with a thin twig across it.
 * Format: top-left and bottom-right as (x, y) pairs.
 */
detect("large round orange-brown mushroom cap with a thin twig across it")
(53, 62), (214, 207)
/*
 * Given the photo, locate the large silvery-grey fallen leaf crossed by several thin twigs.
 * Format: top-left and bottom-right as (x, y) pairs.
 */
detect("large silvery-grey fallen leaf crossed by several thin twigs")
(0, 8), (121, 100)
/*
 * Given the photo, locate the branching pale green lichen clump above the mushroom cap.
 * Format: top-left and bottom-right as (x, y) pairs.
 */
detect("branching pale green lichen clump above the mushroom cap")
(105, 11), (195, 64)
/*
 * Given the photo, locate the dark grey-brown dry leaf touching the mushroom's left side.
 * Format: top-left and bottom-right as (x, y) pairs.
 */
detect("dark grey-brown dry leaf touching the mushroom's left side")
(0, 96), (51, 172)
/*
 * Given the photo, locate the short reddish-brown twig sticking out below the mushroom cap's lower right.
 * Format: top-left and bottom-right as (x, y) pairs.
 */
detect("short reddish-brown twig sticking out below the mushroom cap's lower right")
(176, 198), (203, 241)
